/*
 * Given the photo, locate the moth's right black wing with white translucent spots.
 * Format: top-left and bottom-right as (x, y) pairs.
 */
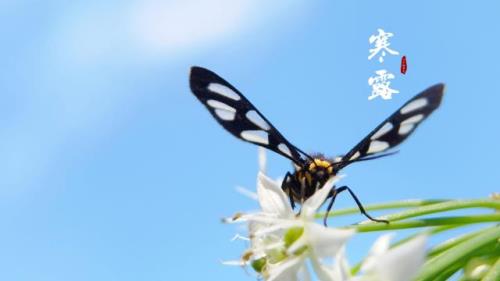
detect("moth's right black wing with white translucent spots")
(339, 84), (444, 168)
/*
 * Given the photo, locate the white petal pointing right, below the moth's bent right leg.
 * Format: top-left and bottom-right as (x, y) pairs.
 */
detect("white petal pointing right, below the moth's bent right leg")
(304, 222), (356, 257)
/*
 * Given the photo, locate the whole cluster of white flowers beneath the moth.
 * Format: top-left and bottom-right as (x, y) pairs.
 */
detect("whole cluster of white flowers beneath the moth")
(229, 148), (426, 281)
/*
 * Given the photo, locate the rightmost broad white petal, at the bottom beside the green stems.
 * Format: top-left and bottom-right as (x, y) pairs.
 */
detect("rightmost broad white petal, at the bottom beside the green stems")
(374, 235), (427, 281)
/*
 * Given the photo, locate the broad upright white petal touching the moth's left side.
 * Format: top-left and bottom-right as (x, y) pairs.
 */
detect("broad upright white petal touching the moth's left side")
(257, 172), (294, 218)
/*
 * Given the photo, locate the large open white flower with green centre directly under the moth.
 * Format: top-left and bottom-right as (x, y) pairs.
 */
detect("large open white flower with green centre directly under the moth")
(227, 148), (355, 281)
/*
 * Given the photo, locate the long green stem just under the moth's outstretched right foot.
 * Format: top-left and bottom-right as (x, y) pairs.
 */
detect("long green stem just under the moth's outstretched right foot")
(347, 213), (500, 232)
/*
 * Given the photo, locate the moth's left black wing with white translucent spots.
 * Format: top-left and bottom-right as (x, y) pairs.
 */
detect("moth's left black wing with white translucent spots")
(189, 66), (305, 165)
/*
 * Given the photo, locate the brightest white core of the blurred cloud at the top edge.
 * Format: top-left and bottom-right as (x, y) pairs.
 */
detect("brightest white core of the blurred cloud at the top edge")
(132, 0), (254, 53)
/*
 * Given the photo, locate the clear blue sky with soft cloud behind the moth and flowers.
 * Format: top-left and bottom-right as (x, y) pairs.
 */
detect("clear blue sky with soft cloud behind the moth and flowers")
(0, 0), (500, 281)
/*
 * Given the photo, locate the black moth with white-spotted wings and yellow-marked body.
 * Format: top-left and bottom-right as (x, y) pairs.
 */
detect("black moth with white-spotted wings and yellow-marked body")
(189, 66), (444, 225)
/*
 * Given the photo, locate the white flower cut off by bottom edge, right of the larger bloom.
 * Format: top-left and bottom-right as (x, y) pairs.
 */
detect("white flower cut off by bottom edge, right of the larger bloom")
(332, 234), (427, 281)
